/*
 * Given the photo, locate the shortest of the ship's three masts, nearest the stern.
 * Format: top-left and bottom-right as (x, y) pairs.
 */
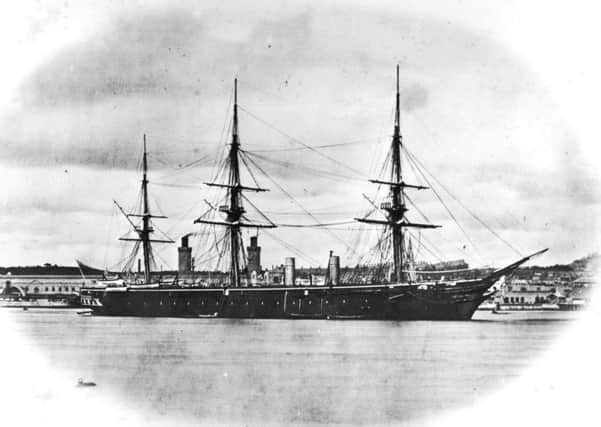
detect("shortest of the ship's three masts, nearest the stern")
(113, 134), (174, 283)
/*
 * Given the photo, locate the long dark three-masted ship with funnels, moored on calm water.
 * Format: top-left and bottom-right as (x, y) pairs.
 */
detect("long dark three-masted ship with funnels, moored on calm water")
(82, 65), (547, 321)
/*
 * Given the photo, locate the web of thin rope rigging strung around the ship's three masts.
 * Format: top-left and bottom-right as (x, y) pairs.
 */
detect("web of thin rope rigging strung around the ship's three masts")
(101, 78), (522, 277)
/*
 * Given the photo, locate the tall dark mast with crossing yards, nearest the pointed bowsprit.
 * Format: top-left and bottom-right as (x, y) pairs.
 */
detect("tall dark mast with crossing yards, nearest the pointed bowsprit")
(355, 64), (439, 282)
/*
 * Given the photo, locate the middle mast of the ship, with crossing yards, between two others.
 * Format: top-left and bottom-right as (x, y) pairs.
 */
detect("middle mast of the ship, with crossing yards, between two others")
(194, 79), (276, 287)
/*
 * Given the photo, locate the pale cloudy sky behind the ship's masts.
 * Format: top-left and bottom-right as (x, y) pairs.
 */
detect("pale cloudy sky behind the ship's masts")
(0, 1), (601, 269)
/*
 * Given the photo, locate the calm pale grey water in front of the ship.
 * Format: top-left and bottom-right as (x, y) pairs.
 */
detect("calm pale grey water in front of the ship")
(5, 309), (576, 425)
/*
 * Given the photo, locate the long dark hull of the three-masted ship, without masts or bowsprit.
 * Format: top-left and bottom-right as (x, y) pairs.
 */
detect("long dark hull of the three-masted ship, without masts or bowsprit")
(85, 281), (492, 320)
